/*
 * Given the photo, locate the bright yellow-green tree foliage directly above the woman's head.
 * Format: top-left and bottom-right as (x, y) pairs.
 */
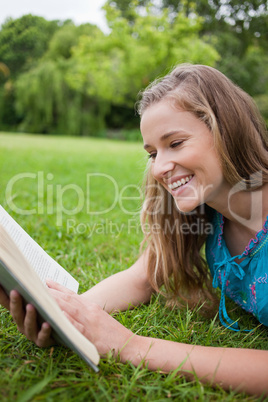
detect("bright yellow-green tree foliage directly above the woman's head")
(68, 1), (218, 107)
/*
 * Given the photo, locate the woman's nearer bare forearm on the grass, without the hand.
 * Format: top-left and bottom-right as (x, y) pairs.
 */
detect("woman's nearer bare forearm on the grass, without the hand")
(124, 335), (268, 396)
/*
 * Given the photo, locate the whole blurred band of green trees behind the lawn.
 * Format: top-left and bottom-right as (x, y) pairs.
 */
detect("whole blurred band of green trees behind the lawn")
(0, 0), (268, 140)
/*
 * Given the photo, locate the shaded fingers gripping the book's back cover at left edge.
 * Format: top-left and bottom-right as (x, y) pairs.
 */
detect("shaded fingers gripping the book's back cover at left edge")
(0, 287), (55, 347)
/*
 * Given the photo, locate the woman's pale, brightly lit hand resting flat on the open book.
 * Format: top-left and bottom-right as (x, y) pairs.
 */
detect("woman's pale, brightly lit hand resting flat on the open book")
(47, 280), (134, 355)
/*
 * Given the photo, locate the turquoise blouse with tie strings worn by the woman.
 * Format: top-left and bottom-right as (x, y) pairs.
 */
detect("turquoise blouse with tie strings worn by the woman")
(206, 212), (268, 331)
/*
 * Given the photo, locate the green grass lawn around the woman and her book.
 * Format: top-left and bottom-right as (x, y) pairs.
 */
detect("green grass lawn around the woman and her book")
(0, 134), (268, 402)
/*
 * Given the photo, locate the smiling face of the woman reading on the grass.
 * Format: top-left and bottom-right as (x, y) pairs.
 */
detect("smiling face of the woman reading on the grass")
(141, 100), (229, 212)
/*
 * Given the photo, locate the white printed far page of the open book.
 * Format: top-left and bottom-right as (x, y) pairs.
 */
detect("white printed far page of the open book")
(0, 205), (79, 293)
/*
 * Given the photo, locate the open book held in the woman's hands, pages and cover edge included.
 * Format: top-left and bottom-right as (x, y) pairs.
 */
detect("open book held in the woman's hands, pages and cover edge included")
(0, 205), (99, 372)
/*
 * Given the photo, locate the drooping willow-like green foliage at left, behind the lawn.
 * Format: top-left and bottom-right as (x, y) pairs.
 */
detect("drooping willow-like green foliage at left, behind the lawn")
(16, 59), (106, 135)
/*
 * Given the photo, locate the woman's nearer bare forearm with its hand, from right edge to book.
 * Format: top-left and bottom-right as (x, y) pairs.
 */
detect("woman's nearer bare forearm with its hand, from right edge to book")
(48, 289), (268, 395)
